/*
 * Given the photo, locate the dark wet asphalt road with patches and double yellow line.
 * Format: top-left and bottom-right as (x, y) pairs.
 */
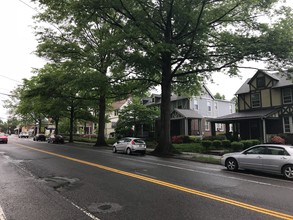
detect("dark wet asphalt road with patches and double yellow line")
(0, 136), (293, 220)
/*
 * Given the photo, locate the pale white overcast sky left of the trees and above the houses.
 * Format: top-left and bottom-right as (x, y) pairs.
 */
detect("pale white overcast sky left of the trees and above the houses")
(0, 0), (293, 120)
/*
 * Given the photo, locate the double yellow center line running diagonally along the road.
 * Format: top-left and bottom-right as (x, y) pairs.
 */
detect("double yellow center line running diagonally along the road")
(18, 144), (293, 220)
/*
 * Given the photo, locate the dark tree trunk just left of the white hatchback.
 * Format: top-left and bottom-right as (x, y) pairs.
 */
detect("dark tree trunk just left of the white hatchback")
(94, 95), (107, 147)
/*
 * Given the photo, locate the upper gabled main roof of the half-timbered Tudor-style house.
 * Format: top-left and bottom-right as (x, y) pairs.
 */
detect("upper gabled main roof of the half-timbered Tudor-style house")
(235, 70), (293, 95)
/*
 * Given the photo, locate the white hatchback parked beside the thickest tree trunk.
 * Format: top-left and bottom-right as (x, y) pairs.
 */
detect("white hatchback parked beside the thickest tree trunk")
(113, 137), (146, 154)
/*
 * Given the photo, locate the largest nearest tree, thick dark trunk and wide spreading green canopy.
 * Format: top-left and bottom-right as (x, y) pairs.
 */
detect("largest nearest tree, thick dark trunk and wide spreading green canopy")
(28, 0), (293, 154)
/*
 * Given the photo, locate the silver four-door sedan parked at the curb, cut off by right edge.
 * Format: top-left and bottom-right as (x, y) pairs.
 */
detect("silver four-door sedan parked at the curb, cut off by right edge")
(221, 144), (293, 180)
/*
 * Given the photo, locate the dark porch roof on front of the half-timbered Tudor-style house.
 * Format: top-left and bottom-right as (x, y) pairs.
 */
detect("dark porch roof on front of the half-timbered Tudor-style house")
(209, 108), (279, 123)
